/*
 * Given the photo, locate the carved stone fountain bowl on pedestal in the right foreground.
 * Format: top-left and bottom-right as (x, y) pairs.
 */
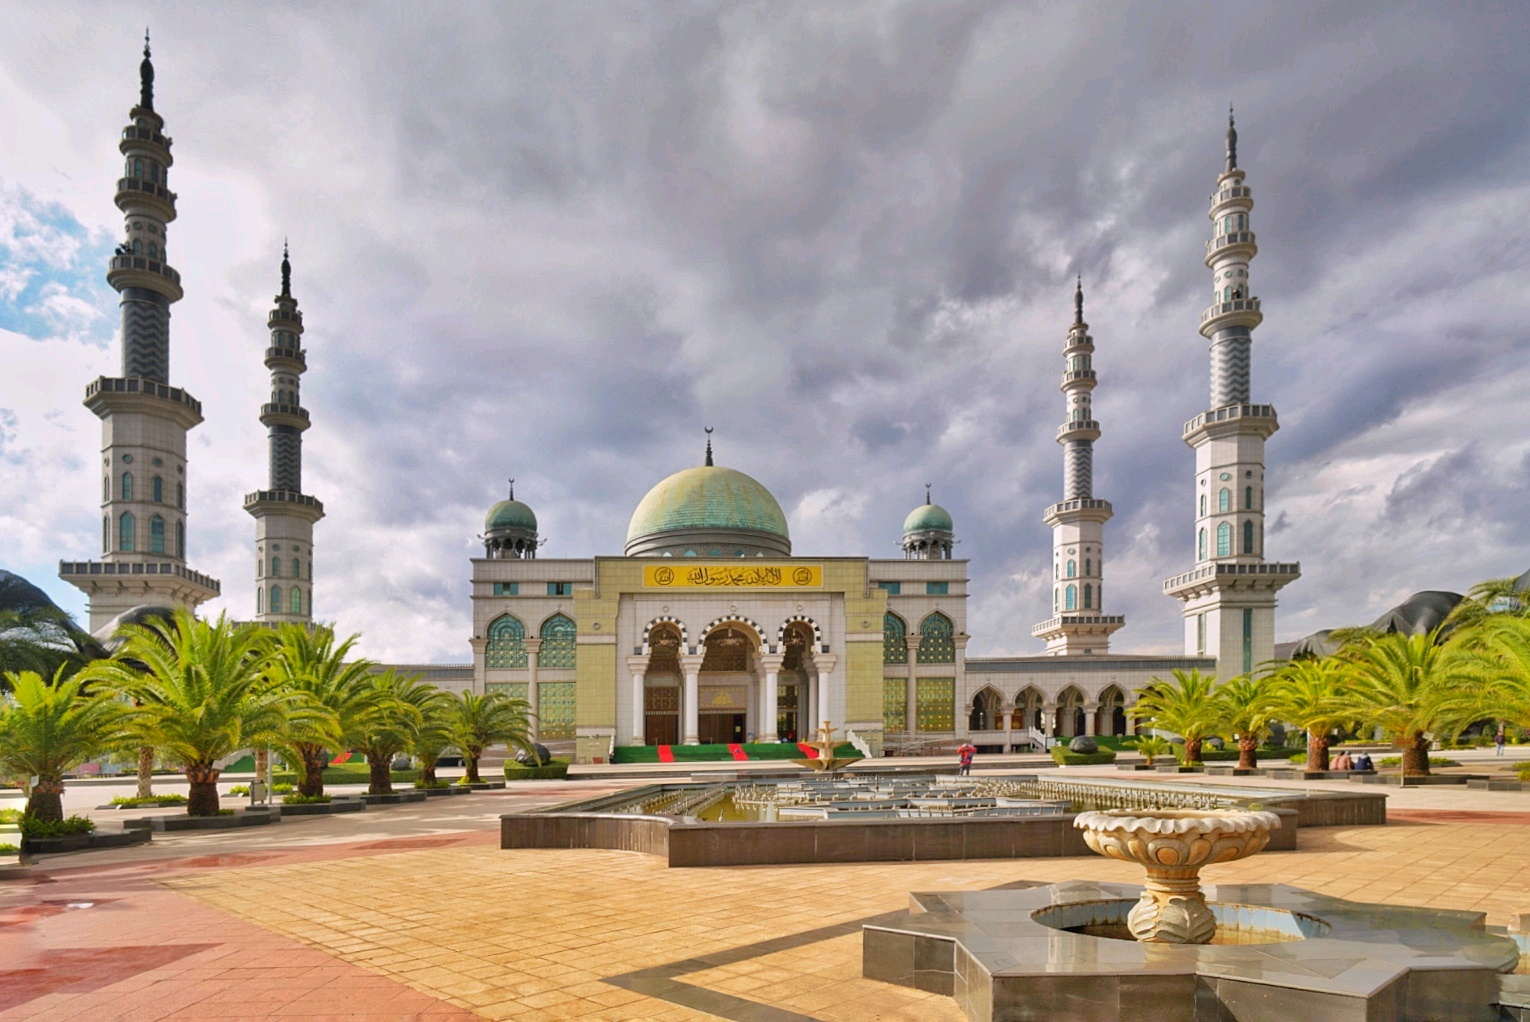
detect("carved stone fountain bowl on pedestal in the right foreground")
(1073, 809), (1281, 944)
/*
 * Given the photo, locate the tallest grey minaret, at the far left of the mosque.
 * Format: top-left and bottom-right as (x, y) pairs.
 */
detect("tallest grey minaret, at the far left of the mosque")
(58, 32), (219, 632)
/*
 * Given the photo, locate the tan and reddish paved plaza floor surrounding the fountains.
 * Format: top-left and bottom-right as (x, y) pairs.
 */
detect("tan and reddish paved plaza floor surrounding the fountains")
(0, 770), (1530, 1022)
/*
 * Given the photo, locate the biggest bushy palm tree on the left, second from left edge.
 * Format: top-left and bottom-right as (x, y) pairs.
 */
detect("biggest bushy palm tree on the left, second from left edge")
(81, 607), (299, 815)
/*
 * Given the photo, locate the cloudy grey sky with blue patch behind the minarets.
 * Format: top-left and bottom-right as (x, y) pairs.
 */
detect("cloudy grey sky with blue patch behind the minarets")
(0, 0), (1530, 662)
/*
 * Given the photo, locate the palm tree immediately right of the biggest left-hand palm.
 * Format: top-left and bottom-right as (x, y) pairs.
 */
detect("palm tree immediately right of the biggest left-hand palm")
(266, 624), (375, 797)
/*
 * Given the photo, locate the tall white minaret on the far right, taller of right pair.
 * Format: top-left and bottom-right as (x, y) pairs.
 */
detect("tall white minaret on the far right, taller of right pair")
(1163, 110), (1302, 681)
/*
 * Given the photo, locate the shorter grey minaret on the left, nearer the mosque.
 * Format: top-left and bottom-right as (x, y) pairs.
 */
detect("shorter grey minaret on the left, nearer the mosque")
(245, 245), (324, 623)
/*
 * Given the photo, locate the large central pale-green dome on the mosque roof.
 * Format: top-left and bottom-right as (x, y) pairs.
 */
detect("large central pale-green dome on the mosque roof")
(627, 465), (791, 545)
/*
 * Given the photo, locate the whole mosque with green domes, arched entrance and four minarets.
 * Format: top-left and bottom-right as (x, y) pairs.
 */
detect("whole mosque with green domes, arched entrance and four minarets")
(47, 38), (1301, 762)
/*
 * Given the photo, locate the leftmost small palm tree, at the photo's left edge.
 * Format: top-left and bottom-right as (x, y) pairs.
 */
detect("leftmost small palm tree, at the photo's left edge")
(0, 664), (132, 820)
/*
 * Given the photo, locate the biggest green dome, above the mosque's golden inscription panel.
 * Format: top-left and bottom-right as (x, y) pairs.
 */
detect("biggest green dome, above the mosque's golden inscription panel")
(627, 465), (791, 557)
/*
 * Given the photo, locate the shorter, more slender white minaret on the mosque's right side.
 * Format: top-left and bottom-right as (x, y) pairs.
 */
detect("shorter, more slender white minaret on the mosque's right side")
(1031, 277), (1126, 656)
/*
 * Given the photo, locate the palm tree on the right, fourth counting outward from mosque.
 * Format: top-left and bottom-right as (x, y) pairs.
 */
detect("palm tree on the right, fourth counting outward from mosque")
(1337, 629), (1478, 777)
